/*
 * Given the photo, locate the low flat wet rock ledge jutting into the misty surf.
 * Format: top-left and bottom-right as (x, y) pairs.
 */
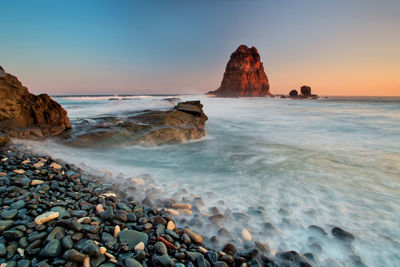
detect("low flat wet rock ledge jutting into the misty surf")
(63, 101), (208, 147)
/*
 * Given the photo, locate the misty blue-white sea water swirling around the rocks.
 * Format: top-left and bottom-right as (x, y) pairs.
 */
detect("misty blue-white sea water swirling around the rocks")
(19, 95), (400, 266)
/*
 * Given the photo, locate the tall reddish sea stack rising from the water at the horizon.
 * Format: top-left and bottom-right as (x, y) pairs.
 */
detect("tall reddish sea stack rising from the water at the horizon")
(208, 45), (270, 97)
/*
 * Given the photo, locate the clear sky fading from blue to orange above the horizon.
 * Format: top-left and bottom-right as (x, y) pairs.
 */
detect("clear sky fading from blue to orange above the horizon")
(0, 0), (400, 96)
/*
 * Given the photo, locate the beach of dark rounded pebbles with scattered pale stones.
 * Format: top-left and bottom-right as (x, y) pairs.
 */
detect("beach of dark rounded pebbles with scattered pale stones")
(0, 145), (322, 267)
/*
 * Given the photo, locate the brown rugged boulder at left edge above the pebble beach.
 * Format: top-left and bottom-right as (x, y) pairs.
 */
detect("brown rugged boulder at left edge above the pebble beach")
(0, 67), (71, 139)
